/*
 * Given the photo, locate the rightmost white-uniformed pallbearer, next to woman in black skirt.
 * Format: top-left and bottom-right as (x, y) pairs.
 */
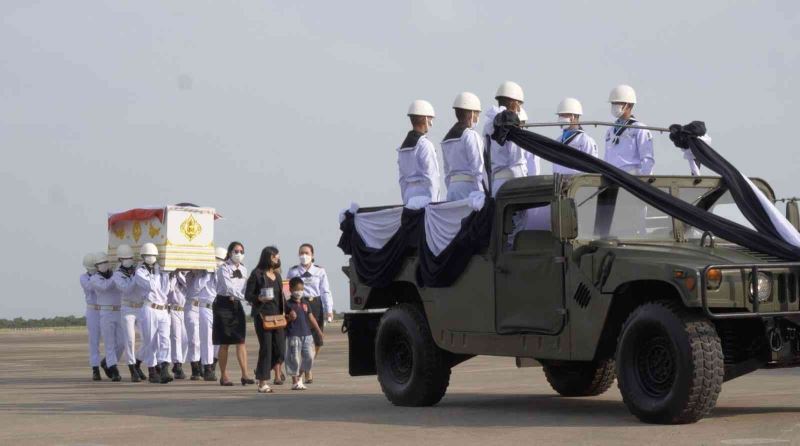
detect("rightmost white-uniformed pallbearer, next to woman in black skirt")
(186, 247), (228, 381)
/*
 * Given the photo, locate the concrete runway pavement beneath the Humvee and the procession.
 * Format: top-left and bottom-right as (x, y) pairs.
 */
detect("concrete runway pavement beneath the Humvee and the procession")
(0, 327), (800, 446)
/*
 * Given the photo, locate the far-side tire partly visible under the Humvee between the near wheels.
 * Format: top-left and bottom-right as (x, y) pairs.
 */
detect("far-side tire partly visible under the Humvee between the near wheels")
(542, 358), (617, 396)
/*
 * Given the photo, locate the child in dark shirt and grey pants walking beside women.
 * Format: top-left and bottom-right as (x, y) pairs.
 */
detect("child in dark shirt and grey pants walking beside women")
(286, 277), (322, 390)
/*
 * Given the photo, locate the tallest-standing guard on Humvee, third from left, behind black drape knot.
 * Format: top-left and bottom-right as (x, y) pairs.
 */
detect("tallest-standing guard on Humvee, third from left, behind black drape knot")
(483, 81), (539, 196)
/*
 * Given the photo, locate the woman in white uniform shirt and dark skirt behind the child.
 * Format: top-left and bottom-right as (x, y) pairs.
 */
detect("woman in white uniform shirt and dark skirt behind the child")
(286, 243), (333, 384)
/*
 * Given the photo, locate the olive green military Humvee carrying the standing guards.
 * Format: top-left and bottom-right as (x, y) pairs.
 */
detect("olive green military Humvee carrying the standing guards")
(343, 174), (800, 423)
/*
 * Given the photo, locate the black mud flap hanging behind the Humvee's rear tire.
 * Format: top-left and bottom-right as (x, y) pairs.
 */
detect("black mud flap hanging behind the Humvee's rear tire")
(342, 312), (383, 376)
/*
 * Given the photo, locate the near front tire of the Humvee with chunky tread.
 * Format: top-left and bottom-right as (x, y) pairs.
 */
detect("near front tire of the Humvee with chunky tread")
(616, 301), (725, 424)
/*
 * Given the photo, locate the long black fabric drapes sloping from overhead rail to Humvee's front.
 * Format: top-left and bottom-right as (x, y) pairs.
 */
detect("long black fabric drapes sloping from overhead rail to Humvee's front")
(492, 112), (800, 260)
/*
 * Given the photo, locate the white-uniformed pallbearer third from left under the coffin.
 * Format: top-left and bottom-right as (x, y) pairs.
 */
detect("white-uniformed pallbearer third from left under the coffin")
(111, 245), (146, 383)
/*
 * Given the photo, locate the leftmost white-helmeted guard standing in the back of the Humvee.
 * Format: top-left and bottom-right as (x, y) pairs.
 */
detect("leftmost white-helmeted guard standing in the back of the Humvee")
(397, 99), (439, 205)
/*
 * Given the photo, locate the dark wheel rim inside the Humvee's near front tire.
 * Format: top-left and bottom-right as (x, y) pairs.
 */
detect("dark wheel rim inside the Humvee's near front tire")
(634, 336), (675, 398)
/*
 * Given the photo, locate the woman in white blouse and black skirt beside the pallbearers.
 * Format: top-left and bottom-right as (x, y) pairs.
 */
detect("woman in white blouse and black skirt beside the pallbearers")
(212, 242), (255, 386)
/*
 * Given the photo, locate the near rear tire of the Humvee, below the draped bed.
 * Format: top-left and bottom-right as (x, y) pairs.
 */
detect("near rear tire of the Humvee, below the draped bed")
(375, 304), (450, 406)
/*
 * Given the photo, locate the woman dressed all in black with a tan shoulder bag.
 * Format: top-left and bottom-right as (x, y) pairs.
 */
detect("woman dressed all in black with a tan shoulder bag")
(245, 246), (286, 393)
